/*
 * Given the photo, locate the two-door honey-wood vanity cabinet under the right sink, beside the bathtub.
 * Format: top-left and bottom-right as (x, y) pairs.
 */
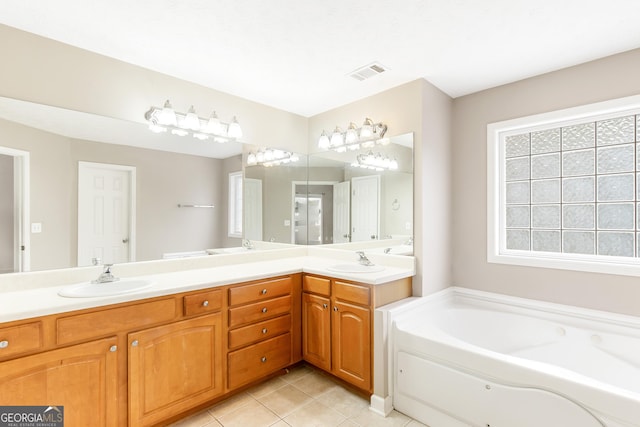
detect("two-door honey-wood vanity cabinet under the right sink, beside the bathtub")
(302, 274), (411, 393)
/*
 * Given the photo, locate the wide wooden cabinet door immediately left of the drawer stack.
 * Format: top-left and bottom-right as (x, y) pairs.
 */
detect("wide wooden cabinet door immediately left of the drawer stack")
(129, 313), (223, 427)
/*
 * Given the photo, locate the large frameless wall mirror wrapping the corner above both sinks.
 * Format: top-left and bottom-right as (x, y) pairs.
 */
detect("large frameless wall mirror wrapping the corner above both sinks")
(0, 97), (413, 273)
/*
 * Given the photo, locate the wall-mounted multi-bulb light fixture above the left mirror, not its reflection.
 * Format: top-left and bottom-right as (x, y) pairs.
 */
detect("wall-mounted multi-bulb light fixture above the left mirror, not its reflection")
(144, 100), (242, 143)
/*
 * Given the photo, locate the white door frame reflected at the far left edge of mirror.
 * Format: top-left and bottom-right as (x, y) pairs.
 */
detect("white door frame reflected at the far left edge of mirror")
(0, 147), (31, 272)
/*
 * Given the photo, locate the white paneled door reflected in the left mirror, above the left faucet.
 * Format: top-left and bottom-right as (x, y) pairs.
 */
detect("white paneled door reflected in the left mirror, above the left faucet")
(78, 162), (135, 266)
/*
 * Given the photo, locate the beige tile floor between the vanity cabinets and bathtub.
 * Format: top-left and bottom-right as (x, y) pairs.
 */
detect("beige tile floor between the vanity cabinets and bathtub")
(171, 365), (426, 427)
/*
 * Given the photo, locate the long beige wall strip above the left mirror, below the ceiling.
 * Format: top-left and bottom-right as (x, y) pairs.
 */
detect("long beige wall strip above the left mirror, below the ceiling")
(0, 25), (307, 152)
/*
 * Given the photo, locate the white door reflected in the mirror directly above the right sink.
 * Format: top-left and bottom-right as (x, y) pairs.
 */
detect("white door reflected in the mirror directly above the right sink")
(351, 175), (380, 242)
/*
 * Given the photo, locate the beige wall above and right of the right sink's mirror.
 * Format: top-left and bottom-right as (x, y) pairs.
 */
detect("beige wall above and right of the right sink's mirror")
(309, 79), (452, 295)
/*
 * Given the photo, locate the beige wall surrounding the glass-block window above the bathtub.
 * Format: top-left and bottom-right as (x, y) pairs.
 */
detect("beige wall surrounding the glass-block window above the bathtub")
(452, 50), (640, 315)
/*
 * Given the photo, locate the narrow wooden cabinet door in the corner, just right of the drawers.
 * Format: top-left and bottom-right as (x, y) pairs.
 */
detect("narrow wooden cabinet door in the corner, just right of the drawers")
(302, 292), (331, 371)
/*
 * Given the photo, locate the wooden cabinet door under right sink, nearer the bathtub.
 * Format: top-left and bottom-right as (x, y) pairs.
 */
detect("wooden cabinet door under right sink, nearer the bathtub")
(331, 301), (372, 392)
